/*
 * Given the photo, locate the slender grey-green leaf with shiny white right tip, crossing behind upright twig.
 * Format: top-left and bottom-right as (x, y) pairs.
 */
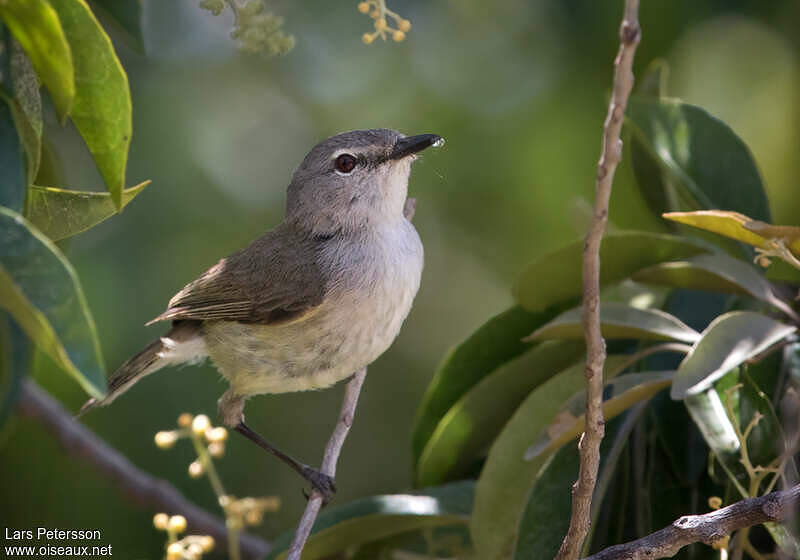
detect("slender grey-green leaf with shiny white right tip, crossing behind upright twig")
(524, 302), (700, 343)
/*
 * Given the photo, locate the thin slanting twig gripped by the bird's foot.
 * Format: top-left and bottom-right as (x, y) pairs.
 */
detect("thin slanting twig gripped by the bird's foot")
(288, 368), (367, 560)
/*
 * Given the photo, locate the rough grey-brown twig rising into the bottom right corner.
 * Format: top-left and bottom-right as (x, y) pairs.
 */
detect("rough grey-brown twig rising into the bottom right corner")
(586, 484), (800, 560)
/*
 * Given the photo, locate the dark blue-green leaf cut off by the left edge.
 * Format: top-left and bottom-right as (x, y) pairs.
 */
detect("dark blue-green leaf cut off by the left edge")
(0, 93), (26, 211)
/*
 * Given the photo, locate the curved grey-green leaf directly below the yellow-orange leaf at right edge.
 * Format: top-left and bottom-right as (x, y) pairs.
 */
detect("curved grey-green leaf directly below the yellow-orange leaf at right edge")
(633, 253), (798, 319)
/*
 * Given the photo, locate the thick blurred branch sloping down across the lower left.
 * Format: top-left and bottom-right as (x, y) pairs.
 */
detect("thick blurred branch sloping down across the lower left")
(14, 379), (270, 559)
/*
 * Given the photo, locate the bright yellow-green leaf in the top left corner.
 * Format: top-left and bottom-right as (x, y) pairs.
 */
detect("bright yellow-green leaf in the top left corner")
(0, 0), (75, 119)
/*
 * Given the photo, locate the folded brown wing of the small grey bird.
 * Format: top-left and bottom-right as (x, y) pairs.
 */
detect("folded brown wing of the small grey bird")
(148, 227), (326, 325)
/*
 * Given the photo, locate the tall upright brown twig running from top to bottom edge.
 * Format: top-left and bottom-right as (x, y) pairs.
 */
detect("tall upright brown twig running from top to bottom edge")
(556, 4), (641, 560)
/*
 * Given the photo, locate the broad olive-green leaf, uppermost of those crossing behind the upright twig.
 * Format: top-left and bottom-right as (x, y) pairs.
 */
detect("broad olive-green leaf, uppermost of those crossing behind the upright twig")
(513, 231), (708, 312)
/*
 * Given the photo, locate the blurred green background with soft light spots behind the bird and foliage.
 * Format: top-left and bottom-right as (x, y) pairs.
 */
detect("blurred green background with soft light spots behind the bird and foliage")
(0, 0), (800, 559)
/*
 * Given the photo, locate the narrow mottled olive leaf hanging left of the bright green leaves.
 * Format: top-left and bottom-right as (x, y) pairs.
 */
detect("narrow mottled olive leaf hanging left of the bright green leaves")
(7, 41), (42, 184)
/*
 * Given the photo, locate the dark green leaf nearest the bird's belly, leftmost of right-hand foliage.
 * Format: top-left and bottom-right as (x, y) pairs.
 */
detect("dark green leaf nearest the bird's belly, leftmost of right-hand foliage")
(412, 302), (575, 470)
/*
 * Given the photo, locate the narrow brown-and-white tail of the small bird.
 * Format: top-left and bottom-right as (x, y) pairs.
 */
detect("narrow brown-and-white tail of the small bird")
(75, 321), (206, 418)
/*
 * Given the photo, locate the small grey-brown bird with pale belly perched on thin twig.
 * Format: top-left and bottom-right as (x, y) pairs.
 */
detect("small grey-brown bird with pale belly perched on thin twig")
(79, 129), (444, 498)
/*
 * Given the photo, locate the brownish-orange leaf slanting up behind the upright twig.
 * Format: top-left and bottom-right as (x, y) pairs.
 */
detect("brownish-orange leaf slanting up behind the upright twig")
(525, 368), (675, 460)
